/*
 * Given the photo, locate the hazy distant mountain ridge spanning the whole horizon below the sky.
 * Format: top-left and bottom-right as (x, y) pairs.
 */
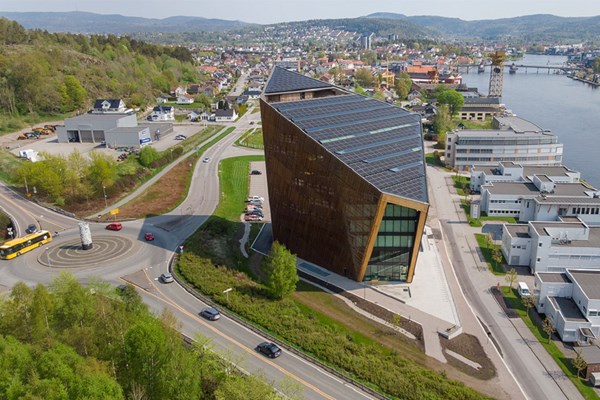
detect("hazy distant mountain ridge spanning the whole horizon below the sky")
(0, 11), (600, 42)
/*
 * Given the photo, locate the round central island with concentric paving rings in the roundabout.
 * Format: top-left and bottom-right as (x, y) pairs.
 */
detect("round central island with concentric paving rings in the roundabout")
(37, 235), (138, 268)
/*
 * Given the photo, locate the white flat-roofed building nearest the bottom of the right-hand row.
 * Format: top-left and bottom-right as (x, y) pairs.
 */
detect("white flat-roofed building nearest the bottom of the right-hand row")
(534, 264), (600, 345)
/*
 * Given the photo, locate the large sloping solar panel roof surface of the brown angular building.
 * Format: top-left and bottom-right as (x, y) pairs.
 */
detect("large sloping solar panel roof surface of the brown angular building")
(271, 92), (428, 202)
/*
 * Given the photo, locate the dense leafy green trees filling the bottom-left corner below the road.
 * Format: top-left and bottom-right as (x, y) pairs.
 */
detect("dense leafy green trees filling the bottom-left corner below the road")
(0, 273), (280, 400)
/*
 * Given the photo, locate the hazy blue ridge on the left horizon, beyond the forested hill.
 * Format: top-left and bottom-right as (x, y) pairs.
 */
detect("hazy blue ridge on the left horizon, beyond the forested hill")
(0, 11), (253, 34)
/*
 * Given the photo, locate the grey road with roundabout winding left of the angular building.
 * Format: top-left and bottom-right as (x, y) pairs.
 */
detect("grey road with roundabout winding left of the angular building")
(0, 98), (373, 400)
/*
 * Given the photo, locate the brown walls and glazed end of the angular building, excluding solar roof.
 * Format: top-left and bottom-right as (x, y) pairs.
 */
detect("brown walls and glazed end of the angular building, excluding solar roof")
(261, 67), (428, 282)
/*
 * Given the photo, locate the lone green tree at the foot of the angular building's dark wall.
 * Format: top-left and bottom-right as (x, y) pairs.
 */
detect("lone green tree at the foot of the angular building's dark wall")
(263, 241), (298, 299)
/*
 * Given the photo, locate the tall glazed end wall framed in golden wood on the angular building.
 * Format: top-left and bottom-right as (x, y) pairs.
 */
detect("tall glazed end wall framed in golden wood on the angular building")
(364, 203), (419, 282)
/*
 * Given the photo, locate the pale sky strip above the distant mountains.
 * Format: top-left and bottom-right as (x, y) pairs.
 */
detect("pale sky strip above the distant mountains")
(0, 0), (600, 24)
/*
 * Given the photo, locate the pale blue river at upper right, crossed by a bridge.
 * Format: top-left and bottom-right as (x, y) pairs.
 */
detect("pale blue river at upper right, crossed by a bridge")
(461, 55), (600, 188)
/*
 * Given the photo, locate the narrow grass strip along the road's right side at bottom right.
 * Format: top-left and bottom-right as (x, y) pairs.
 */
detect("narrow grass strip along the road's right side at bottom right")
(500, 286), (600, 400)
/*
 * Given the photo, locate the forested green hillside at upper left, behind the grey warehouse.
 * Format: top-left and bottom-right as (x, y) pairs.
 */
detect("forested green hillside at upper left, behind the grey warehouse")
(0, 18), (201, 116)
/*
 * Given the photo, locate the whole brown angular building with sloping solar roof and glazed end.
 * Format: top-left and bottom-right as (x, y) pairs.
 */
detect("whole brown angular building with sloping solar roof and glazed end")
(261, 67), (429, 282)
